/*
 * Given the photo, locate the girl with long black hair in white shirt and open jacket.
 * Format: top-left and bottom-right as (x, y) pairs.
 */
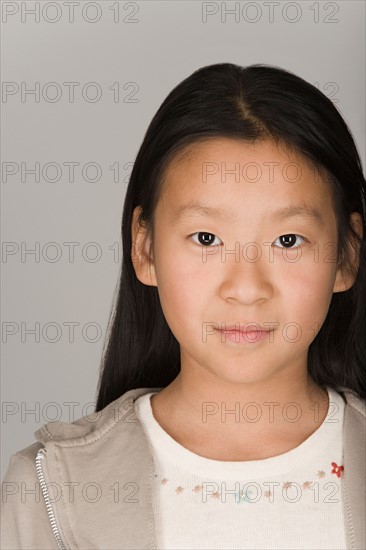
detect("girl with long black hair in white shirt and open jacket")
(3, 63), (366, 550)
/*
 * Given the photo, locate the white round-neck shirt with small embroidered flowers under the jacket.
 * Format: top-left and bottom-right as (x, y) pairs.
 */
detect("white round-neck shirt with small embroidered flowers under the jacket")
(137, 387), (347, 550)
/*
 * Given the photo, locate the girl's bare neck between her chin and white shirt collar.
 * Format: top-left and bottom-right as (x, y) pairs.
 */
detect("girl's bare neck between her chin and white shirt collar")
(151, 362), (328, 460)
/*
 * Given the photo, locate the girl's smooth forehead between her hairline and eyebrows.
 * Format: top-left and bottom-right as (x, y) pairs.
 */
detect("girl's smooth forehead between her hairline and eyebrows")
(161, 137), (332, 208)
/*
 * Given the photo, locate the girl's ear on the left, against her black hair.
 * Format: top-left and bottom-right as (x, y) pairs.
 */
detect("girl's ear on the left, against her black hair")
(131, 206), (158, 286)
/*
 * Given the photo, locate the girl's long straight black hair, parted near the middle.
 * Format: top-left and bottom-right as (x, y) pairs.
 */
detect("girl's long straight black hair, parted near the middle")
(95, 63), (366, 412)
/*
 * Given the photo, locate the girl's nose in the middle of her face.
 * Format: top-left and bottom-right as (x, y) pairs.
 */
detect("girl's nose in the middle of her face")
(220, 246), (273, 305)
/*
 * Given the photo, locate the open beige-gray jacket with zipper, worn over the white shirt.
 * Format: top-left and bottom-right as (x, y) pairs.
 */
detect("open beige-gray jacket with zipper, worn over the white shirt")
(1, 387), (366, 550)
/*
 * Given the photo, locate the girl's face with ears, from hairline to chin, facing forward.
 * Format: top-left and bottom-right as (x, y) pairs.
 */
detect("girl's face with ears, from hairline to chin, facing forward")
(133, 138), (353, 383)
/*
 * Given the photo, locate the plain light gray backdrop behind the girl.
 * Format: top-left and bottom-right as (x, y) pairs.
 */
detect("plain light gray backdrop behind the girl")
(1, 0), (365, 477)
